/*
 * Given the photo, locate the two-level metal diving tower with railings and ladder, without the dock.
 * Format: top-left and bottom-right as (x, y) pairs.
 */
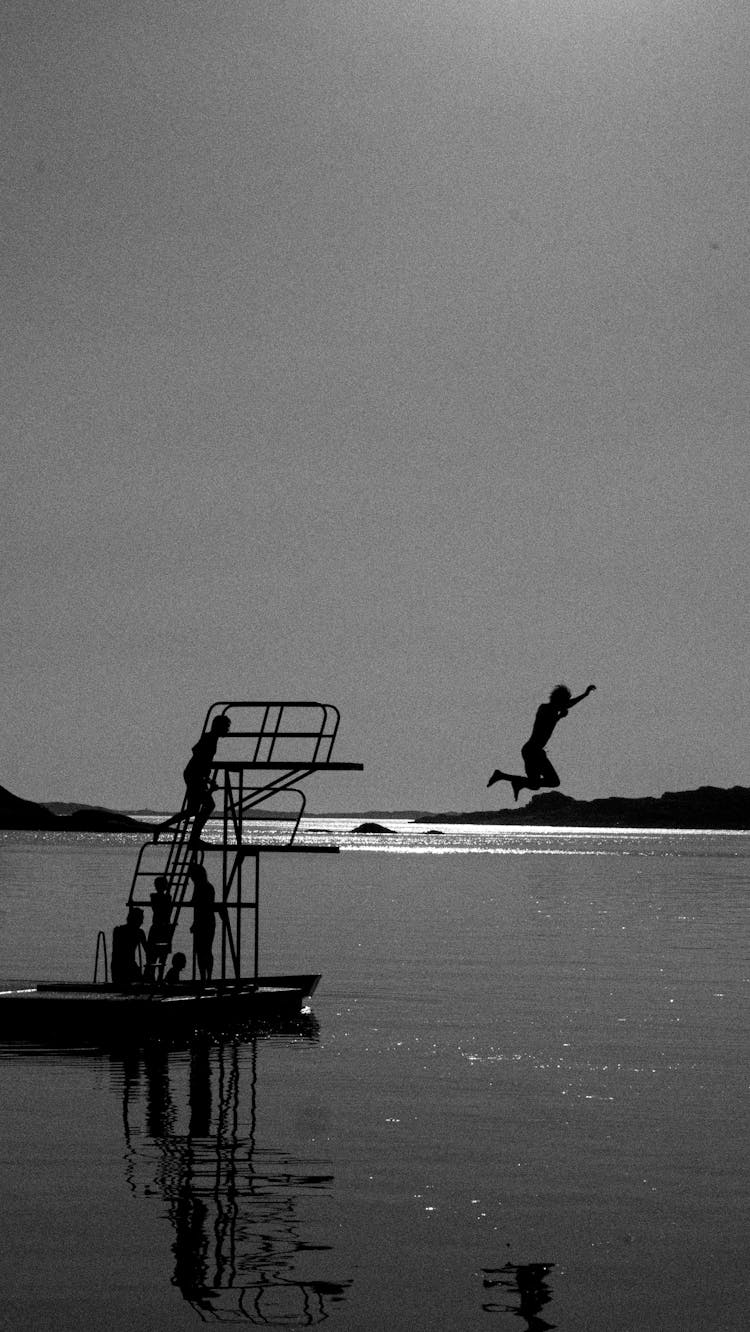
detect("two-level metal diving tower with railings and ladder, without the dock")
(128, 701), (362, 984)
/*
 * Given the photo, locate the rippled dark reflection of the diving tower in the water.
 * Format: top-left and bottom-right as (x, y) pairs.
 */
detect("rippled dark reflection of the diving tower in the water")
(117, 1019), (352, 1327)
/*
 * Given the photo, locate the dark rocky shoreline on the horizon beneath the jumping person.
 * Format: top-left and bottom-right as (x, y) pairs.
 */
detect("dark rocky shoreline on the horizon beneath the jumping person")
(413, 786), (750, 831)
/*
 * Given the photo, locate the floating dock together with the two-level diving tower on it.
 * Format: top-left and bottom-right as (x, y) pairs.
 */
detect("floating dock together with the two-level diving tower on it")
(0, 701), (362, 1043)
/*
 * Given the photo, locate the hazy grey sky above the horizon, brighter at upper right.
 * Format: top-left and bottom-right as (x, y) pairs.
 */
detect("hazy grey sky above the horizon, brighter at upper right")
(0, 0), (750, 811)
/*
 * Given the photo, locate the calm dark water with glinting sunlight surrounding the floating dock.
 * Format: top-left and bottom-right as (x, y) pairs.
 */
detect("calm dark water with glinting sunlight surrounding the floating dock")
(0, 821), (750, 1332)
